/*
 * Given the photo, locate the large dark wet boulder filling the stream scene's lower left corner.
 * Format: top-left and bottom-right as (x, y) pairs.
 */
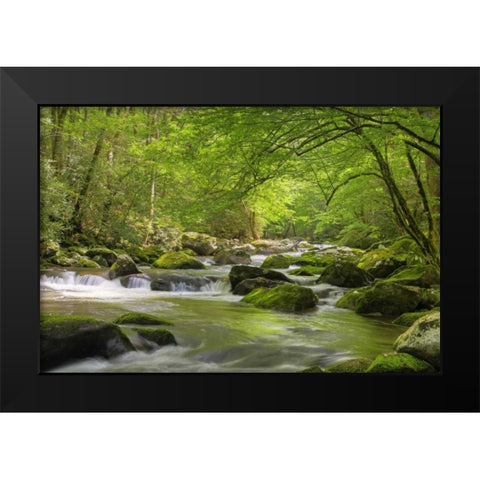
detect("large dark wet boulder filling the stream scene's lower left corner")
(40, 315), (135, 371)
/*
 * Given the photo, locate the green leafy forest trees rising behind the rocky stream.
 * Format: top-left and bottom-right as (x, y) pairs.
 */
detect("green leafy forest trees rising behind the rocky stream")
(40, 106), (440, 264)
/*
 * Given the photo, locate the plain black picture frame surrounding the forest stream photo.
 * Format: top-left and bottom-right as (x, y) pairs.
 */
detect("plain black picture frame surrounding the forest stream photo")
(0, 67), (480, 412)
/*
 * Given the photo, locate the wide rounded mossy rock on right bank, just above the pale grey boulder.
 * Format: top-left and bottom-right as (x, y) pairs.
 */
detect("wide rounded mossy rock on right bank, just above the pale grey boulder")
(355, 282), (422, 316)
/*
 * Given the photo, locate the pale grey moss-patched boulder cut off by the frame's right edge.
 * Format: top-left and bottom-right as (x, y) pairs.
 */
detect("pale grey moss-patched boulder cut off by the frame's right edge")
(394, 312), (440, 368)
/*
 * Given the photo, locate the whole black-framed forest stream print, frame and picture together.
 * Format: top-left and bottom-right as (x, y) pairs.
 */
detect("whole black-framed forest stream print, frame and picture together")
(1, 68), (480, 412)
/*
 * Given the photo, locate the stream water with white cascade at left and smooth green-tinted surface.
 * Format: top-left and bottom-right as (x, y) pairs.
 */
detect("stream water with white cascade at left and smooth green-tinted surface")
(40, 249), (405, 372)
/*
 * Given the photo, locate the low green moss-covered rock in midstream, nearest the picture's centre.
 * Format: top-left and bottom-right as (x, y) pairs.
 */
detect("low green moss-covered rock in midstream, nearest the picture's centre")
(242, 284), (318, 312)
